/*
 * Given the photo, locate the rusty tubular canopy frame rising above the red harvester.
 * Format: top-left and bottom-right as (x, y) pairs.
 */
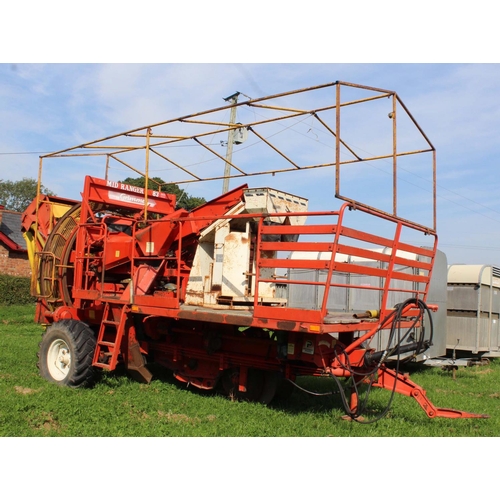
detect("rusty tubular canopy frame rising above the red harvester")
(39, 81), (436, 234)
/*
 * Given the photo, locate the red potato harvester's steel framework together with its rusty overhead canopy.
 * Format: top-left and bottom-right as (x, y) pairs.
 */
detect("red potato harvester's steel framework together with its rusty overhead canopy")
(20, 82), (484, 418)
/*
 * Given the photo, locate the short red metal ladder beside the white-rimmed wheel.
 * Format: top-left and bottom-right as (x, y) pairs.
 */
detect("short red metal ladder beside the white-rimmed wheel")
(92, 302), (128, 370)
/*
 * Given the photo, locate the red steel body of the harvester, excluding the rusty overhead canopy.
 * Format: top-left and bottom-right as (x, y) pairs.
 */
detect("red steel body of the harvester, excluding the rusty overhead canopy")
(23, 177), (488, 418)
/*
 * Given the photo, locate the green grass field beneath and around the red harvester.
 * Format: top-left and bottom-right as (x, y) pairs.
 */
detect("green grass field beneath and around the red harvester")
(0, 306), (500, 437)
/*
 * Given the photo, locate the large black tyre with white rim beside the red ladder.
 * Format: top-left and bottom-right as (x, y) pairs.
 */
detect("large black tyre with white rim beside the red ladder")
(38, 320), (96, 387)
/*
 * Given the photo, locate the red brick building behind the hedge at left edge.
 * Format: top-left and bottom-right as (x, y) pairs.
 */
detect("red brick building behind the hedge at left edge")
(0, 205), (31, 276)
